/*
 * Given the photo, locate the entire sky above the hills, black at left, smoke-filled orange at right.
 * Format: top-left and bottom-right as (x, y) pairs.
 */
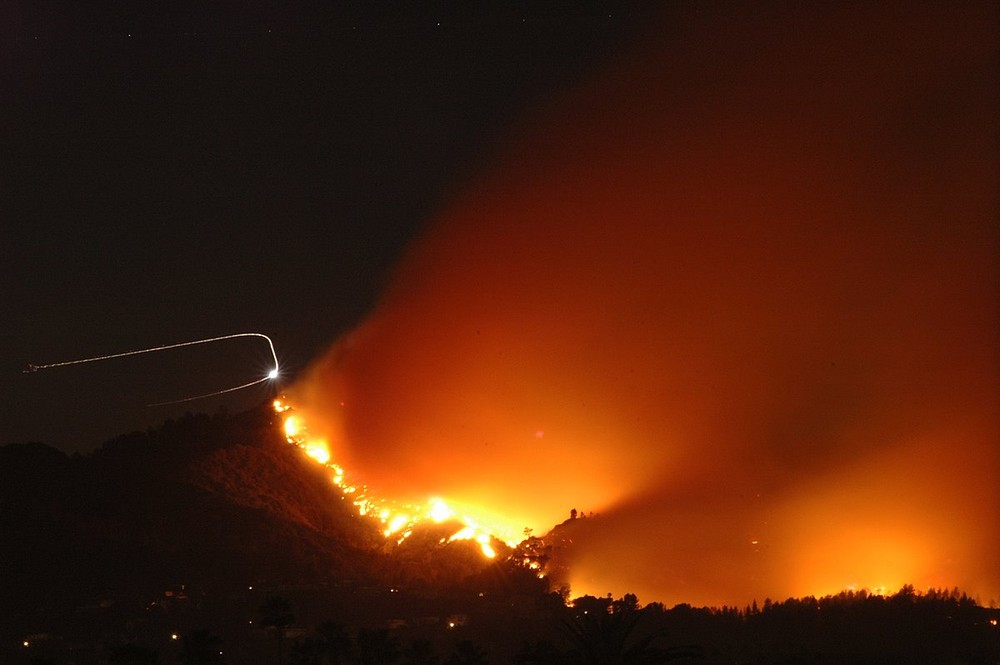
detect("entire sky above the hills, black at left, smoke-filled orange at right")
(0, 2), (1000, 604)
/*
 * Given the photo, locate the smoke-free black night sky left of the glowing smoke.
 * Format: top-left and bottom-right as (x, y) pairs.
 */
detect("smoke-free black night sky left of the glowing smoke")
(0, 2), (646, 450)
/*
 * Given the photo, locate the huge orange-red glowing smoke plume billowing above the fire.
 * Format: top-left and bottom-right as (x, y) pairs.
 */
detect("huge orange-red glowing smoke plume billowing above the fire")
(292, 3), (1000, 603)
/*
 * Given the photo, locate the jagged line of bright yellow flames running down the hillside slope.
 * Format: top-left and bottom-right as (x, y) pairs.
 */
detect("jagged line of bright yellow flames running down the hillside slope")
(274, 399), (508, 559)
